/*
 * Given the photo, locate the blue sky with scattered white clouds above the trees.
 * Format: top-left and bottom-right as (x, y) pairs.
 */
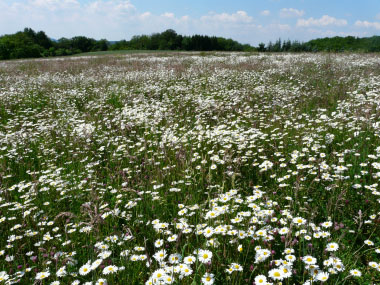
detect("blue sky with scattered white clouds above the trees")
(0, 0), (380, 46)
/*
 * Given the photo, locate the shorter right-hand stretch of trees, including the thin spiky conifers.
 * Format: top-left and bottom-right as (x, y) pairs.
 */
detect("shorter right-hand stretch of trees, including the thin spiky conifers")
(257, 36), (380, 52)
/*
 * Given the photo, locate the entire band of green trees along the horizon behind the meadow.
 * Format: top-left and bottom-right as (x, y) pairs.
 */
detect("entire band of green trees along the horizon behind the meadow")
(0, 28), (380, 60)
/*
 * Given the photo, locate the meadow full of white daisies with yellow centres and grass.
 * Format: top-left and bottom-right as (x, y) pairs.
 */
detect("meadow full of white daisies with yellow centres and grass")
(0, 53), (380, 285)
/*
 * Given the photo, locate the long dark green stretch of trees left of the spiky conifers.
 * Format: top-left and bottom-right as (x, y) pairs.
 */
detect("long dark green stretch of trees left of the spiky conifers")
(0, 28), (254, 60)
